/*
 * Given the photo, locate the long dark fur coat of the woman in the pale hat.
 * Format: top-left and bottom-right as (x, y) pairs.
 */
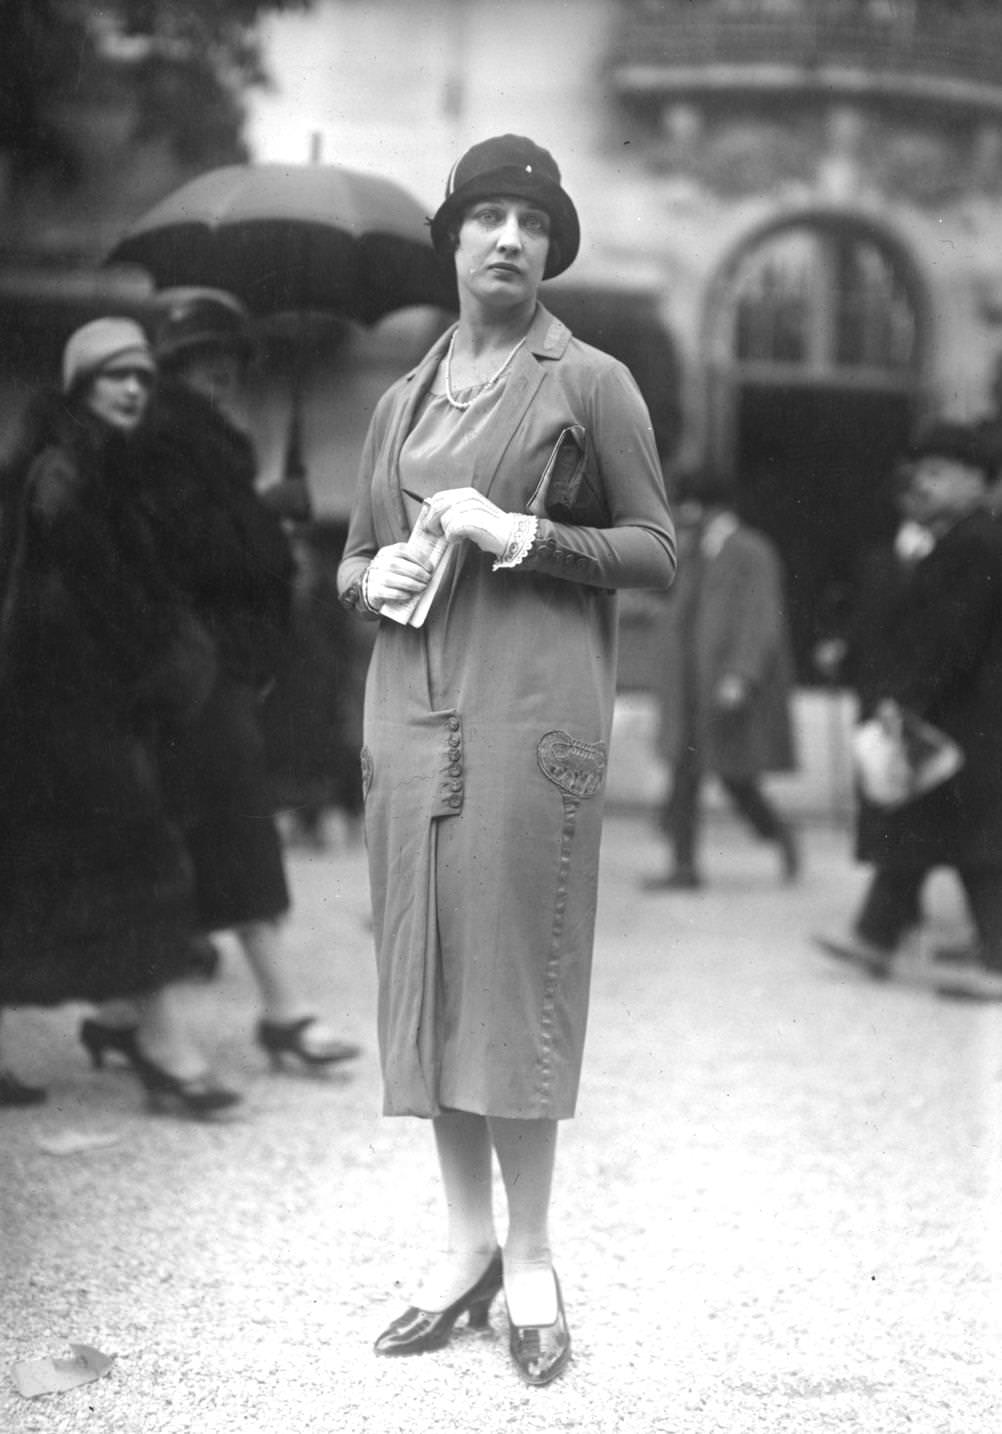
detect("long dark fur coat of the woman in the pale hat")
(0, 396), (204, 1005)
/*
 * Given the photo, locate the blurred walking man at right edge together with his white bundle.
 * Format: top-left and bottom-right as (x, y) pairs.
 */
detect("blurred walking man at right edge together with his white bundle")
(819, 419), (1002, 1001)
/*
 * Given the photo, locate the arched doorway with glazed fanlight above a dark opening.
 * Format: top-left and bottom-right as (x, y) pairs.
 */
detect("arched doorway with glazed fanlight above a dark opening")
(707, 214), (927, 683)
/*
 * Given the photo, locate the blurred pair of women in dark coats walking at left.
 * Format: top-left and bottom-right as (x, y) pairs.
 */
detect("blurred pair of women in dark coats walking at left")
(0, 290), (364, 1119)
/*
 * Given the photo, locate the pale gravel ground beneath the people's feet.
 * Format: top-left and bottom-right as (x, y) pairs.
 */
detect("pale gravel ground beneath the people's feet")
(0, 815), (1002, 1434)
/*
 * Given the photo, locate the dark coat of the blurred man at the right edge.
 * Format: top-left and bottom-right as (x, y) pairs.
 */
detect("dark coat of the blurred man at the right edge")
(857, 512), (1002, 869)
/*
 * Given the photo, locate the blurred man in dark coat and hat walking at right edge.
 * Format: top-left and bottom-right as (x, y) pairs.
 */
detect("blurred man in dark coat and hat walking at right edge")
(829, 423), (1002, 999)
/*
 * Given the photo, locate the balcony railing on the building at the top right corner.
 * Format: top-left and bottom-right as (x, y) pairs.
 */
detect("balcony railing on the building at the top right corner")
(611, 3), (1002, 99)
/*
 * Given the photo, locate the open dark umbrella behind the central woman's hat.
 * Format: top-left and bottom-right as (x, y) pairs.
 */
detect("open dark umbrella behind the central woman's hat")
(106, 163), (454, 324)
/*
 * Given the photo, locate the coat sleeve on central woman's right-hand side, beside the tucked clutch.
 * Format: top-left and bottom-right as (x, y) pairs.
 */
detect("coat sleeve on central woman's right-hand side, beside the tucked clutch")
(522, 360), (677, 588)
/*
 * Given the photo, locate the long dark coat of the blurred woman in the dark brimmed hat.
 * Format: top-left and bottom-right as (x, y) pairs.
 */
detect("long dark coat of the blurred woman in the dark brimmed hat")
(138, 381), (292, 931)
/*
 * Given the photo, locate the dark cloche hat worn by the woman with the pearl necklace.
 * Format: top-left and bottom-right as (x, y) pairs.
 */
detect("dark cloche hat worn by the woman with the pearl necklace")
(431, 135), (581, 278)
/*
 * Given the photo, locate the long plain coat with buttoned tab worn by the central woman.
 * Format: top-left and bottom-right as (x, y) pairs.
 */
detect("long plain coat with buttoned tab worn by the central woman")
(338, 307), (675, 1119)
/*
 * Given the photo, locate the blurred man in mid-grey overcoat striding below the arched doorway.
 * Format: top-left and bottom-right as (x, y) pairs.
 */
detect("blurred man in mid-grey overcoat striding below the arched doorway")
(644, 473), (800, 891)
